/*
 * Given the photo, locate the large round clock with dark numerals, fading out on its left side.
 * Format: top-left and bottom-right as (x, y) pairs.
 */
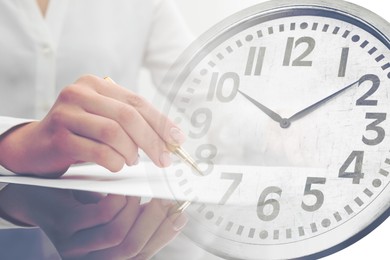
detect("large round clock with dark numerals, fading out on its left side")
(160, 1), (390, 259)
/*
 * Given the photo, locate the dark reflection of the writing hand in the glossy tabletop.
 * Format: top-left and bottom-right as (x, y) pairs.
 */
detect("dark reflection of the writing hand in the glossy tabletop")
(0, 184), (187, 260)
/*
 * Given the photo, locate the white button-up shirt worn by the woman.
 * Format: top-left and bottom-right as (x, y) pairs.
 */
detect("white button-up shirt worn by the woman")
(0, 0), (191, 223)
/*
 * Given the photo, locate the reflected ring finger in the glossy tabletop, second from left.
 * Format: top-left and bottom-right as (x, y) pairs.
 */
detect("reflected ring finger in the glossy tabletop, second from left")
(63, 197), (140, 259)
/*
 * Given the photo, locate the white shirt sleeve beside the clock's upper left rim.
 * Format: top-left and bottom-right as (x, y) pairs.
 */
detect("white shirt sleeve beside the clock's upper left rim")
(144, 0), (193, 88)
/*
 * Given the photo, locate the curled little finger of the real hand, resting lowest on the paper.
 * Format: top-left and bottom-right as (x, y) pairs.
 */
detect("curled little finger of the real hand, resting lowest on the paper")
(55, 129), (125, 172)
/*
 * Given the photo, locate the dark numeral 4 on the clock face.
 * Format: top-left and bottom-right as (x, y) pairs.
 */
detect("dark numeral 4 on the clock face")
(339, 151), (364, 184)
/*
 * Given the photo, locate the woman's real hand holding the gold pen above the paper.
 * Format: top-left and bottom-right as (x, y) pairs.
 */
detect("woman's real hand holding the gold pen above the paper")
(0, 76), (184, 177)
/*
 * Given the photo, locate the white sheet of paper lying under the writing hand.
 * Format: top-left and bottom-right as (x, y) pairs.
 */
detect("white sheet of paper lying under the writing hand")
(0, 162), (324, 206)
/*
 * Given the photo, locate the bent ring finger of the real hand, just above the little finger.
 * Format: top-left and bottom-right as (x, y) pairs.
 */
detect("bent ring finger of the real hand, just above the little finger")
(65, 111), (138, 165)
